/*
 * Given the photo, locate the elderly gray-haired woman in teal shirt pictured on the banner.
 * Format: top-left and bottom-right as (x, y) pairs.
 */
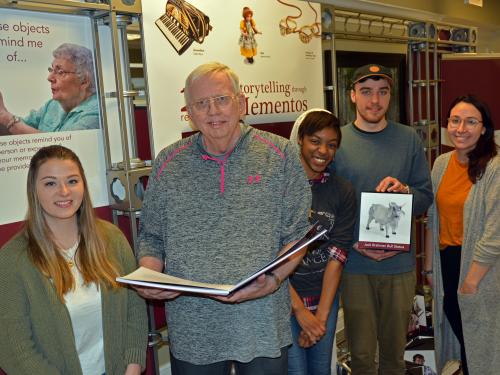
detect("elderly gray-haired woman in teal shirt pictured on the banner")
(0, 43), (99, 135)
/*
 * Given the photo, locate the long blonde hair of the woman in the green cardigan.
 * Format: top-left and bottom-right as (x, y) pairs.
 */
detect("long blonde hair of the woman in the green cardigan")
(24, 145), (118, 301)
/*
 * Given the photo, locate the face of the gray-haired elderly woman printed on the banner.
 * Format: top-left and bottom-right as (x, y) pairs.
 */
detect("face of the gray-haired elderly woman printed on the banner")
(47, 58), (88, 111)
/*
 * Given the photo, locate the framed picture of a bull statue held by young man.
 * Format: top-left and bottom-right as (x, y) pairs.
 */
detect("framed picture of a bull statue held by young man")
(358, 192), (413, 251)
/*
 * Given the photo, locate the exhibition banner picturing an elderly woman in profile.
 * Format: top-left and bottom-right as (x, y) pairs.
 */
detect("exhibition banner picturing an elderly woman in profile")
(0, 9), (108, 225)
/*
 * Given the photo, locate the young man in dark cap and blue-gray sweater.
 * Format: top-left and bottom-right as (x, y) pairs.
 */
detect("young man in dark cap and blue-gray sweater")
(335, 64), (432, 375)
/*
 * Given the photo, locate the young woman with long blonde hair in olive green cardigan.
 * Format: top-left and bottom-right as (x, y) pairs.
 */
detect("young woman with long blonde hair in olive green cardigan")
(0, 145), (147, 375)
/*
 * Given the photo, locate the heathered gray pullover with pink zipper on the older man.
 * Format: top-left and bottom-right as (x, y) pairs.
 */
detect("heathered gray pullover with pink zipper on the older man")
(138, 125), (311, 365)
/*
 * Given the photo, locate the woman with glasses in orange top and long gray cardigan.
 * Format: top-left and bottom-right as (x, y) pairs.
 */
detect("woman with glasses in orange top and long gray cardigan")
(423, 95), (500, 374)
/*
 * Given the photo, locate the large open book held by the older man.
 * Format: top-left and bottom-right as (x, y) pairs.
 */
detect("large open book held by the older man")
(116, 224), (327, 296)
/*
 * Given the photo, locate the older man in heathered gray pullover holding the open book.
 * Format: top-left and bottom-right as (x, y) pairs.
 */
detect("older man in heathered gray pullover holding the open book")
(138, 63), (311, 375)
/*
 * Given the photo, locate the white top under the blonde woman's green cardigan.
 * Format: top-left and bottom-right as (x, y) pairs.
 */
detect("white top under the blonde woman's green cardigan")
(64, 243), (105, 375)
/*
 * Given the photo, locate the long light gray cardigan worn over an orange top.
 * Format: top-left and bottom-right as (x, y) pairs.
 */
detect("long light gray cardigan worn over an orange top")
(428, 151), (500, 375)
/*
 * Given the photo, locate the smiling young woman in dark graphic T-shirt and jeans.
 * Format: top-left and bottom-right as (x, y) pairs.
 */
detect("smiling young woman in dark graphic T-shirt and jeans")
(288, 109), (357, 375)
